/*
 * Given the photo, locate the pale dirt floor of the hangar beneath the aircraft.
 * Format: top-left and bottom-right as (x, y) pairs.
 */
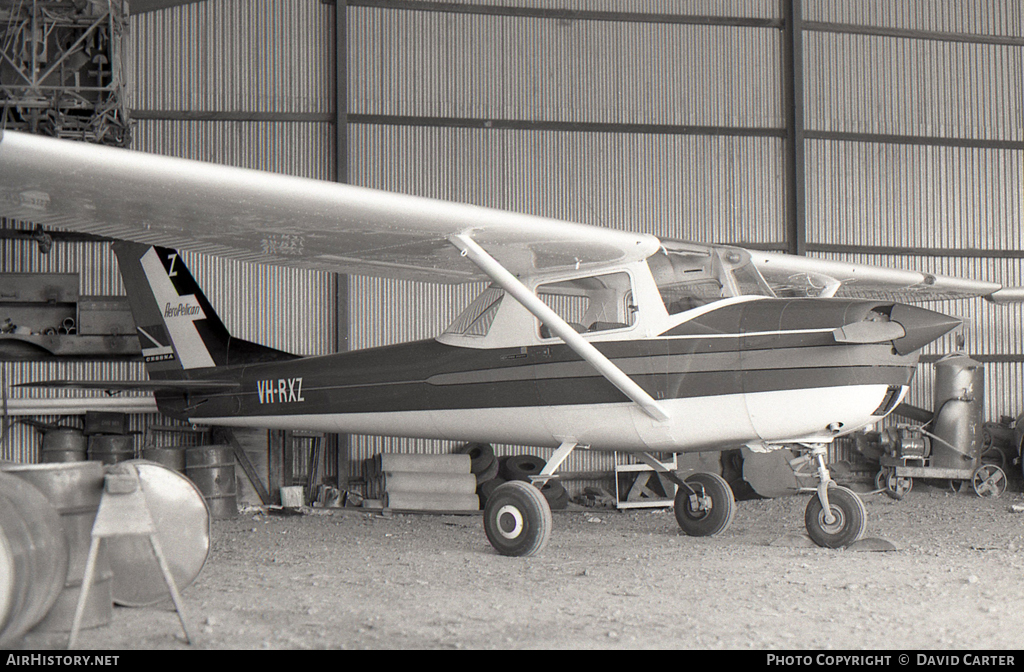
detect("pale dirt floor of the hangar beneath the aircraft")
(22, 477), (1024, 649)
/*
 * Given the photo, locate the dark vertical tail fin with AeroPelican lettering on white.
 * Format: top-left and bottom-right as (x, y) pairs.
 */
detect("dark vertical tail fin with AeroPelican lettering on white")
(114, 242), (294, 380)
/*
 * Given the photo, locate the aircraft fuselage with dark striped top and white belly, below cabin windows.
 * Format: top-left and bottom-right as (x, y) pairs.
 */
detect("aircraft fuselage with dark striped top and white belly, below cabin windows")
(158, 298), (918, 452)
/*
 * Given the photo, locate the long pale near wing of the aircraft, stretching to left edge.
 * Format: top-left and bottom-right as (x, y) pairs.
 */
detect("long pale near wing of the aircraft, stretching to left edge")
(0, 131), (658, 283)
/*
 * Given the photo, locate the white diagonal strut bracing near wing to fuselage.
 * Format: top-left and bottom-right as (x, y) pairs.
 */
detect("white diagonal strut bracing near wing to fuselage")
(449, 234), (669, 422)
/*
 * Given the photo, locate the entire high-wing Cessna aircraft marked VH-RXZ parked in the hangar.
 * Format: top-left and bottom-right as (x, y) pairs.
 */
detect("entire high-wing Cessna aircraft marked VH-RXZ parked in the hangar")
(0, 131), (1022, 555)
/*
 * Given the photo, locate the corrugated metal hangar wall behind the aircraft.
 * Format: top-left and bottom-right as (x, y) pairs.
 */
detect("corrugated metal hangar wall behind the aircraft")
(4, 0), (1024, 487)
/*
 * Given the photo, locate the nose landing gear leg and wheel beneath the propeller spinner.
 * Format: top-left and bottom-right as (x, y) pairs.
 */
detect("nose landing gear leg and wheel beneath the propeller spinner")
(804, 444), (867, 548)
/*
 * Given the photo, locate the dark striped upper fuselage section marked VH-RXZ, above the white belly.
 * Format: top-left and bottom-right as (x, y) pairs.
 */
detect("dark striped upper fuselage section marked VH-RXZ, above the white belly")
(161, 300), (916, 418)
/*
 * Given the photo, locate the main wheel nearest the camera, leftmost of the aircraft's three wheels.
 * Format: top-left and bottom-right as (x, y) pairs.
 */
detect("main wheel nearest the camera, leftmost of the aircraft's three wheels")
(483, 480), (551, 556)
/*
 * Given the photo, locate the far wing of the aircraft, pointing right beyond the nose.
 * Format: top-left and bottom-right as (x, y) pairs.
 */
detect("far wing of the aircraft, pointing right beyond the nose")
(748, 250), (1024, 303)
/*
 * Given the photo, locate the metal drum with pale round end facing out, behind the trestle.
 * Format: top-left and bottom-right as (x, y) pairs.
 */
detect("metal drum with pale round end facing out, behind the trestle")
(105, 460), (210, 606)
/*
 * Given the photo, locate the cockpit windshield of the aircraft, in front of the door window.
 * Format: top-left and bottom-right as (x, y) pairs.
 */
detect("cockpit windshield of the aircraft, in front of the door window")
(647, 247), (774, 314)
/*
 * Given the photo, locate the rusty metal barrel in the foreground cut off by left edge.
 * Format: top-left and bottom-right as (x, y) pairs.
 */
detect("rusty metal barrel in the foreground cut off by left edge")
(0, 473), (68, 648)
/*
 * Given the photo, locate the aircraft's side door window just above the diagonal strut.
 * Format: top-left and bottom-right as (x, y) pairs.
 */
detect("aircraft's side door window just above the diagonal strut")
(537, 272), (636, 338)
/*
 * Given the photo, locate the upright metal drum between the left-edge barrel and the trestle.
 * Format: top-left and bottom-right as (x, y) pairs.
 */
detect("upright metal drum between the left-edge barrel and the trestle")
(4, 462), (114, 632)
